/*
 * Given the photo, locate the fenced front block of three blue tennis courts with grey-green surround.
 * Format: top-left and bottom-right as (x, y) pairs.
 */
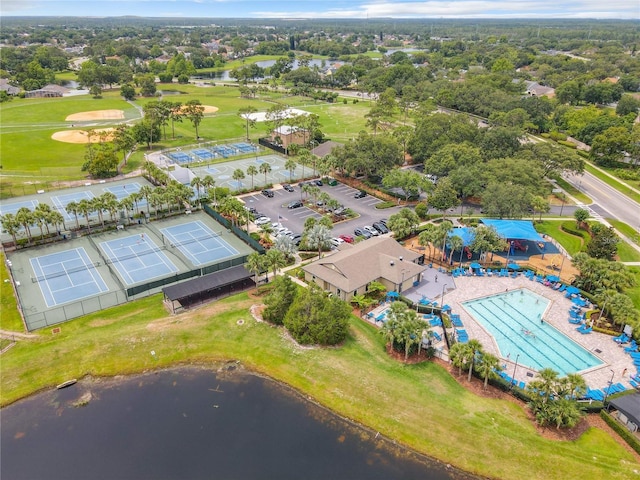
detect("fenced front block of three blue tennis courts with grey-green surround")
(7, 212), (253, 331)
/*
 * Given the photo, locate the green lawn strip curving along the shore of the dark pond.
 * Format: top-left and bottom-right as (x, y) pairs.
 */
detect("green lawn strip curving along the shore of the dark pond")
(0, 294), (640, 480)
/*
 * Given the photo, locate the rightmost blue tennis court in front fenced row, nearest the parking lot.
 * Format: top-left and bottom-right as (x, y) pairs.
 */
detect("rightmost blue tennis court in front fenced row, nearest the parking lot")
(160, 221), (238, 266)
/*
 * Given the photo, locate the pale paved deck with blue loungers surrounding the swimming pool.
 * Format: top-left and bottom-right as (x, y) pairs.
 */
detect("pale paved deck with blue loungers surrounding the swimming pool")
(440, 275), (636, 389)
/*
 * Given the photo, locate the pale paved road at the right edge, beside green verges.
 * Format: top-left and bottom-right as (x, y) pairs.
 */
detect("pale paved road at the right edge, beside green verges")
(565, 172), (640, 233)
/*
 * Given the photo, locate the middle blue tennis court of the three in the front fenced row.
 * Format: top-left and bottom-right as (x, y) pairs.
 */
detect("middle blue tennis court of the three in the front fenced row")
(100, 234), (178, 285)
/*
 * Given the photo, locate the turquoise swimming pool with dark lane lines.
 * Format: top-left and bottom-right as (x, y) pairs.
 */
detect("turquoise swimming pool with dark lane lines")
(462, 288), (602, 376)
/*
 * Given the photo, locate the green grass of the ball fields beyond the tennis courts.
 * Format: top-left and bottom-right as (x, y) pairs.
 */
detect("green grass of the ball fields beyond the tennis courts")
(0, 84), (370, 198)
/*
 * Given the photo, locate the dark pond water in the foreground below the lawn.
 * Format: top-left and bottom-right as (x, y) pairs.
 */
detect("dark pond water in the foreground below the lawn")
(0, 365), (472, 480)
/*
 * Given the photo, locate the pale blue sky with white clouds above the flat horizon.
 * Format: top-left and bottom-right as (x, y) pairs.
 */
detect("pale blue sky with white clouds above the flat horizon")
(0, 0), (640, 20)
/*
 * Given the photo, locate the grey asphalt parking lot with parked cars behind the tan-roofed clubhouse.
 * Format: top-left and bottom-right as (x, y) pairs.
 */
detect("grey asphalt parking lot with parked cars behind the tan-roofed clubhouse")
(241, 183), (398, 237)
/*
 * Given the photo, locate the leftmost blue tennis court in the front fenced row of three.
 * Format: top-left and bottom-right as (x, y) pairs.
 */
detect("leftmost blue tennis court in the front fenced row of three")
(30, 248), (109, 307)
